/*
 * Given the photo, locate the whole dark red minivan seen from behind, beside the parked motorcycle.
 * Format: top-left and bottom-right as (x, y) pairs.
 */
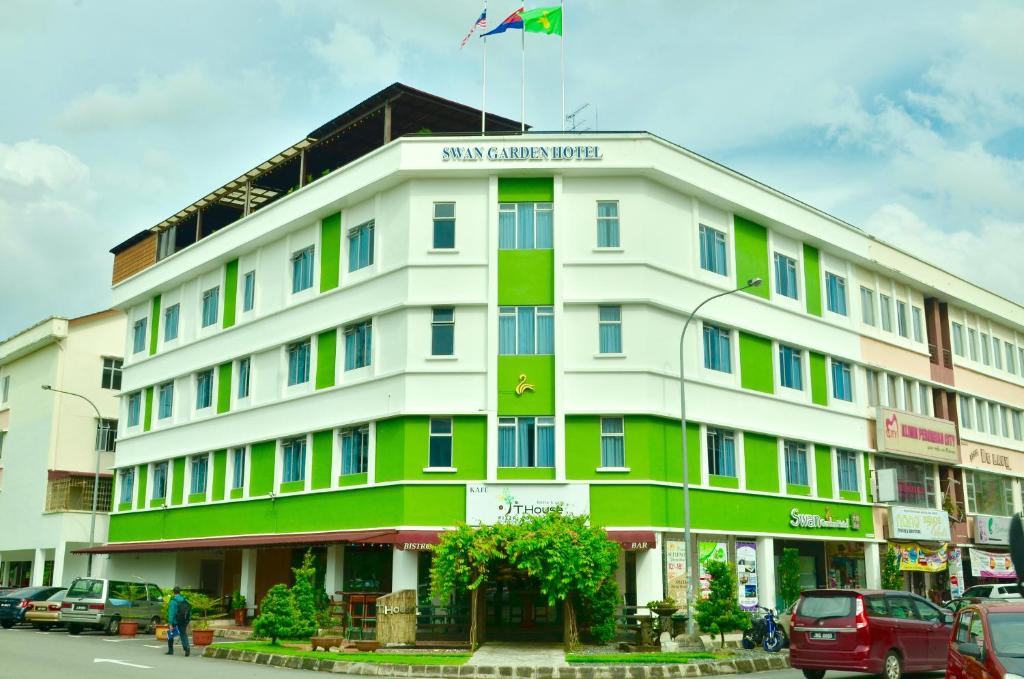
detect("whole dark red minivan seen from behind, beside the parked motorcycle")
(790, 590), (953, 679)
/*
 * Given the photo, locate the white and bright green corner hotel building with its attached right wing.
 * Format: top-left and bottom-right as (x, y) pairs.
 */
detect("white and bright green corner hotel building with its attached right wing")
(97, 86), (1024, 630)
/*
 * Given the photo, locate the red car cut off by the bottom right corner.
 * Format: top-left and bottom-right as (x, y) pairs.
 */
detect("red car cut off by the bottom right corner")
(946, 602), (1024, 679)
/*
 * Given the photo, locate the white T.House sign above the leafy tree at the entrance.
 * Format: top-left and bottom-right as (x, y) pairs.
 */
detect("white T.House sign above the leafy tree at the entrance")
(466, 483), (590, 525)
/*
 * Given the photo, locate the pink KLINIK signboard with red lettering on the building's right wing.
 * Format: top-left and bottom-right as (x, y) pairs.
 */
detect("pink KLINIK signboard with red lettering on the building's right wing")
(874, 407), (959, 464)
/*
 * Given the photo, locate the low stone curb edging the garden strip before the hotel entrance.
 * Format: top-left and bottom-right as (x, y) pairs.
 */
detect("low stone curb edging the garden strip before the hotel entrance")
(203, 646), (790, 679)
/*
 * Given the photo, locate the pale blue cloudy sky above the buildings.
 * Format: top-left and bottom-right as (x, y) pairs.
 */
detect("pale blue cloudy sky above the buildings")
(0, 0), (1024, 338)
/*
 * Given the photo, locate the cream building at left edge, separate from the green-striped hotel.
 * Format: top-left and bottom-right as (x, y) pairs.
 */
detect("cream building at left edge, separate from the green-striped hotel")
(0, 310), (125, 587)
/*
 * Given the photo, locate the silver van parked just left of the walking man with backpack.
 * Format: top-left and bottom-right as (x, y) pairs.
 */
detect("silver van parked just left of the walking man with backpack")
(60, 578), (164, 634)
